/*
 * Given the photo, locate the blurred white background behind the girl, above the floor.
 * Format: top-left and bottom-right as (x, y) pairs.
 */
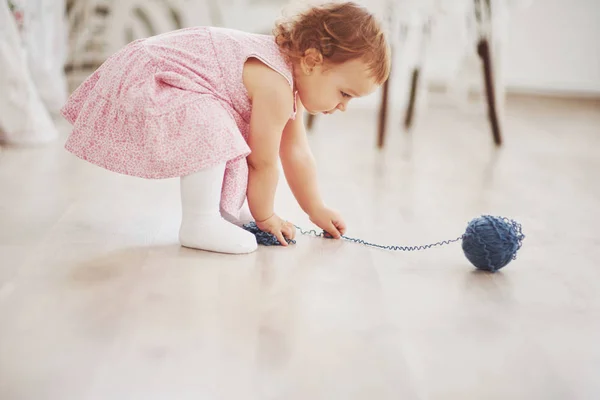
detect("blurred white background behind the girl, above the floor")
(0, 0), (600, 145)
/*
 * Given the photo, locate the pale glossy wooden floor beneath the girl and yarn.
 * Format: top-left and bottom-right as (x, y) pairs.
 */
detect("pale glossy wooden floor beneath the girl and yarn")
(0, 98), (600, 400)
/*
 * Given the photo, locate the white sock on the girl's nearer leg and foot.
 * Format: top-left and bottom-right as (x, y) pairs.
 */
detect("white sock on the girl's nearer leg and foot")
(179, 163), (257, 254)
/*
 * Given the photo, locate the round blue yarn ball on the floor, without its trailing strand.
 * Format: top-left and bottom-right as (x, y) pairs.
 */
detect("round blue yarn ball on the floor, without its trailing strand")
(462, 215), (525, 272)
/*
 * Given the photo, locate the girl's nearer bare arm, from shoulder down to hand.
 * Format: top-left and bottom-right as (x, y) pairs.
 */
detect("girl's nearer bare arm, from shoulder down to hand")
(244, 60), (293, 245)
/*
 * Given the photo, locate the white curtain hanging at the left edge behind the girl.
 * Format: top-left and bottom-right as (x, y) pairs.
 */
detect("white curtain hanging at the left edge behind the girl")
(0, 0), (66, 144)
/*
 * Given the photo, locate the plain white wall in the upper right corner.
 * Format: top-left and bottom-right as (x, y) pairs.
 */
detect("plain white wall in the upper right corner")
(506, 0), (600, 96)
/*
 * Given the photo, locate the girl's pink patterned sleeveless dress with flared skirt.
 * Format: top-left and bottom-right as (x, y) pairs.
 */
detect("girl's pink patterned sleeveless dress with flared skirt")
(62, 27), (296, 217)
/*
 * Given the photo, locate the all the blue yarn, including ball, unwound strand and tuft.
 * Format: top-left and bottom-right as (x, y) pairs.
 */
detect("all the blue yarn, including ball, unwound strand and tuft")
(244, 215), (525, 272)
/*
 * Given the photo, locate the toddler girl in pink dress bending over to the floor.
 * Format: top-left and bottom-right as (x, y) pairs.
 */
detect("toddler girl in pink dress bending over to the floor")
(62, 3), (390, 254)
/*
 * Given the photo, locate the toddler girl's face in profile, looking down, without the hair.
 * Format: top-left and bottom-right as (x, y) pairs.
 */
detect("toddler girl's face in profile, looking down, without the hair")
(296, 55), (377, 114)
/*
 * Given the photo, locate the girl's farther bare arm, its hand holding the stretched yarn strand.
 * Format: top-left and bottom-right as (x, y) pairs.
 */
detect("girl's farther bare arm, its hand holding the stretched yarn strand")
(279, 102), (346, 238)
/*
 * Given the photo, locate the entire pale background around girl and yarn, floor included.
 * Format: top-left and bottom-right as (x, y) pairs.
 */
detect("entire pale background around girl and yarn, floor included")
(0, 0), (600, 400)
